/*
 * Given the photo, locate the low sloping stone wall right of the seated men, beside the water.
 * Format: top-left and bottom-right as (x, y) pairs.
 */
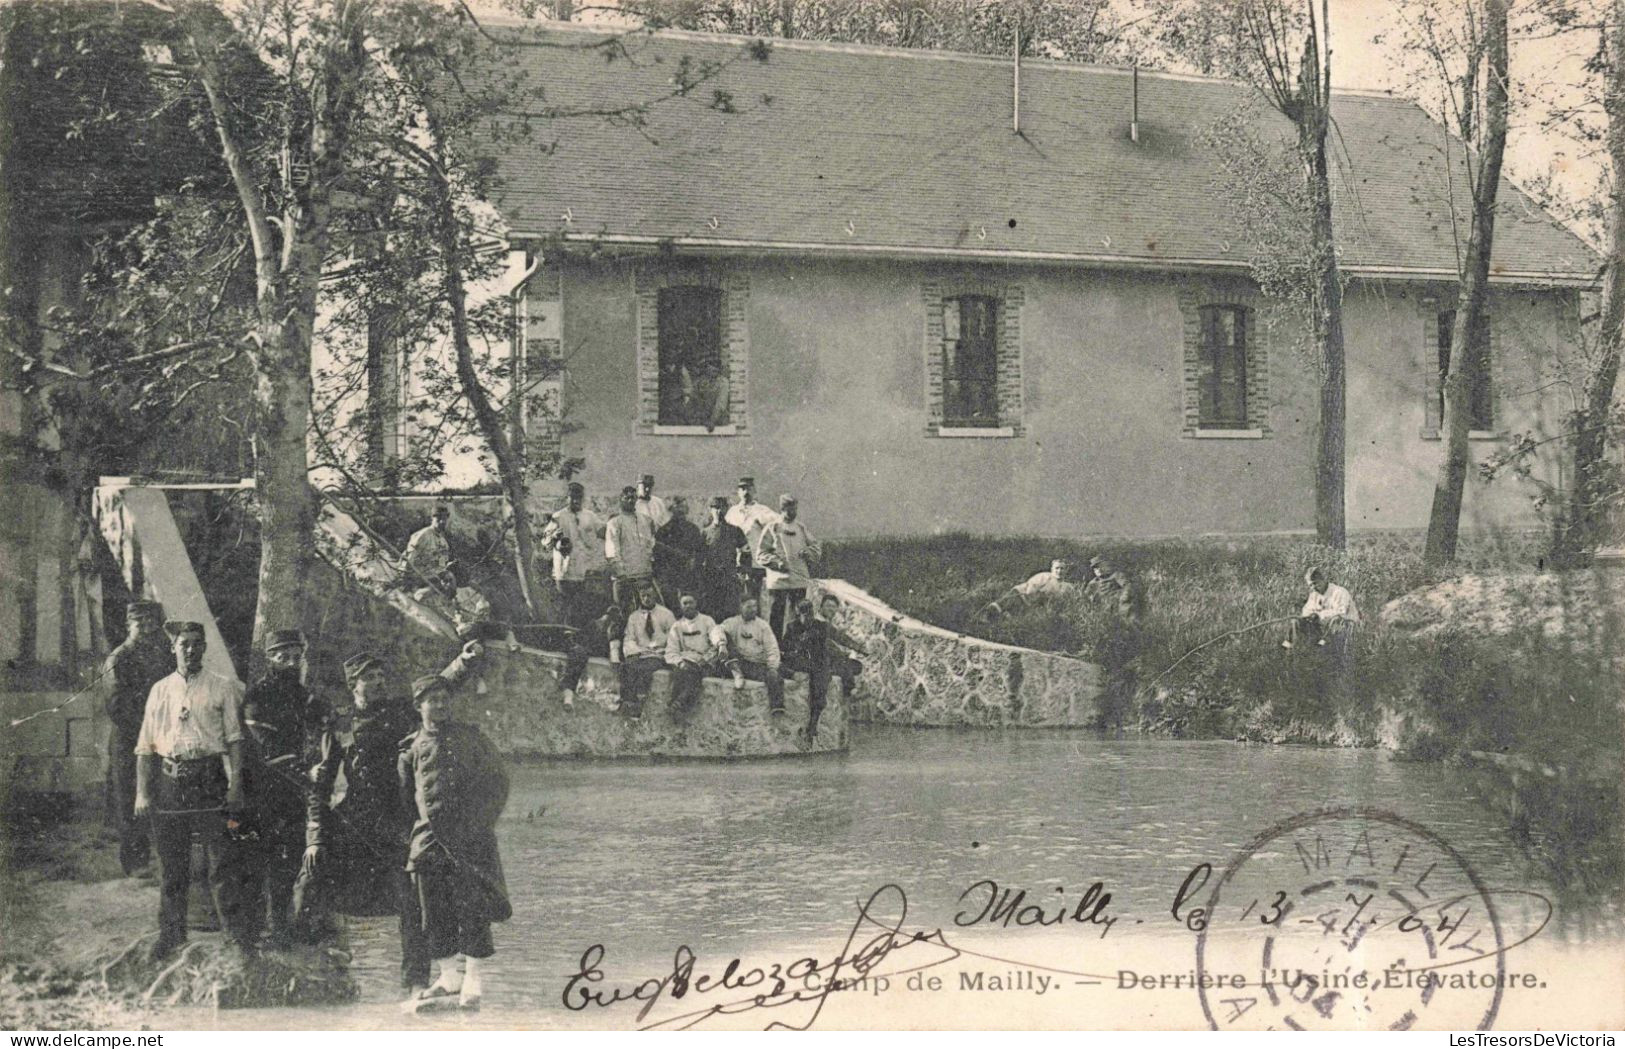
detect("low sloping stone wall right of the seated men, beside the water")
(817, 580), (1103, 727)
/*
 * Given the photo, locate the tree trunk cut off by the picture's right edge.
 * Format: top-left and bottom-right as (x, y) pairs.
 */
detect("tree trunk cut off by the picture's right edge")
(1555, 0), (1625, 563)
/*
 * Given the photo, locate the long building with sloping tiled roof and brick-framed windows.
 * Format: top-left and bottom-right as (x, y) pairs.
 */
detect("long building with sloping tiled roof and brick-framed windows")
(461, 24), (1597, 536)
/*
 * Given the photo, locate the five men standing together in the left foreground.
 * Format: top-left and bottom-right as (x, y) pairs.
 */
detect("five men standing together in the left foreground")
(107, 601), (510, 1007)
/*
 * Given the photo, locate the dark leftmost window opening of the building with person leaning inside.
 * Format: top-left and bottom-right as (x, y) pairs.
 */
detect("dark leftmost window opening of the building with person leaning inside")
(657, 286), (728, 425)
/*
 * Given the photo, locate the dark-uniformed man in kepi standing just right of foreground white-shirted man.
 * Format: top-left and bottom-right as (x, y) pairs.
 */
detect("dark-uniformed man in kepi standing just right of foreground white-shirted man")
(242, 630), (333, 945)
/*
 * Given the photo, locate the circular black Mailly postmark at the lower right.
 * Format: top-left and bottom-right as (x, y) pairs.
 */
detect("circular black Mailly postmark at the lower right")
(1196, 807), (1506, 1031)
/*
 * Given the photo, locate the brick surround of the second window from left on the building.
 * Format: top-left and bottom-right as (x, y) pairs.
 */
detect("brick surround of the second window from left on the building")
(920, 279), (1027, 438)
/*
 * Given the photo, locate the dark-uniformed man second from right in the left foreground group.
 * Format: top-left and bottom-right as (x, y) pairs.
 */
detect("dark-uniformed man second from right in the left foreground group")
(294, 641), (479, 994)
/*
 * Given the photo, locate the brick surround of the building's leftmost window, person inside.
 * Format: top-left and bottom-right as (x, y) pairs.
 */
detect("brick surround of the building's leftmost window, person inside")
(634, 265), (751, 437)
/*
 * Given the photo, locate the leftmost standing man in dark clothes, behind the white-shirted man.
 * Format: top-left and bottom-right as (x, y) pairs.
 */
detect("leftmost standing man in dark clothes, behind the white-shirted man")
(102, 601), (176, 874)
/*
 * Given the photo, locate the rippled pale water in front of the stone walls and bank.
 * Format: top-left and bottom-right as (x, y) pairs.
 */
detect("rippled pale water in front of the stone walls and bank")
(221, 727), (1617, 1028)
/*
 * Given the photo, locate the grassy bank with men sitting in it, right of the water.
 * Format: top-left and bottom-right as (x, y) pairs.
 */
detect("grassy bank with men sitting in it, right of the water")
(822, 534), (1625, 891)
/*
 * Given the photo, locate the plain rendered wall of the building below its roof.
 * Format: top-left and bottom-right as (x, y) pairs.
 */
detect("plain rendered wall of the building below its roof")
(543, 250), (1563, 536)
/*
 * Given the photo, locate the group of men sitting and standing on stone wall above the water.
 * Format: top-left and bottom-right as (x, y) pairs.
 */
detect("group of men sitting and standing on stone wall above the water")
(406, 474), (860, 742)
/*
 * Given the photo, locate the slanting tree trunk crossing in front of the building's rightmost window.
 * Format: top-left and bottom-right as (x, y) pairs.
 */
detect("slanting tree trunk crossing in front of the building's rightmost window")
(1424, 0), (1506, 565)
